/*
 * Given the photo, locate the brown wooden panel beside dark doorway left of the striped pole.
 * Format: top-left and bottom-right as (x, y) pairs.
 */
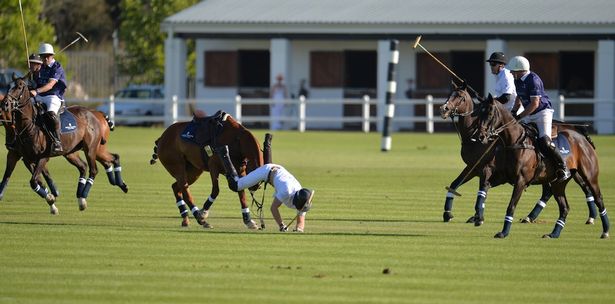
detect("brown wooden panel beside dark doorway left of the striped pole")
(310, 51), (344, 88)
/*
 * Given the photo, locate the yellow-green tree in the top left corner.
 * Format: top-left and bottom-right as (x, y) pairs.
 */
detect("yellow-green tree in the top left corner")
(0, 0), (61, 71)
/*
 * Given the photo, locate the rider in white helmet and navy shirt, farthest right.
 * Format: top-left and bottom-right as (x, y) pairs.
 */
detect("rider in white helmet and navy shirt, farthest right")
(508, 56), (570, 180)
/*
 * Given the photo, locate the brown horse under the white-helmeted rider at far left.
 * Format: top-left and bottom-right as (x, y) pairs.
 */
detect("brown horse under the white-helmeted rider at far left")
(1, 75), (128, 214)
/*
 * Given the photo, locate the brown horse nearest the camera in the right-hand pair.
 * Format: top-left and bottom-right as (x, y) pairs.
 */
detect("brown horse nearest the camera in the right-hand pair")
(478, 96), (610, 238)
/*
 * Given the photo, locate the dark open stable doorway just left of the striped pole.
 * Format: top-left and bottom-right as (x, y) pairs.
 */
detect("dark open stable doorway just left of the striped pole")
(343, 51), (378, 130)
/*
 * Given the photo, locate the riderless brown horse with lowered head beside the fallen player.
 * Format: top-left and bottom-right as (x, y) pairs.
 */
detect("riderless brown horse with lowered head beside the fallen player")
(150, 114), (263, 229)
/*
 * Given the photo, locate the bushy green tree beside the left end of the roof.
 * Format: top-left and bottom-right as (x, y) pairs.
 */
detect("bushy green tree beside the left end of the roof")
(120, 0), (198, 83)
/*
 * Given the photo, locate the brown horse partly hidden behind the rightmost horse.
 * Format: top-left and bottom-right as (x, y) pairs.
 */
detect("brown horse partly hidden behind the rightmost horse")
(440, 83), (597, 226)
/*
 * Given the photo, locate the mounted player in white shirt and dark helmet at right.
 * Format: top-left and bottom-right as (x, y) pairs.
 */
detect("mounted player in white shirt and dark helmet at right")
(487, 52), (517, 111)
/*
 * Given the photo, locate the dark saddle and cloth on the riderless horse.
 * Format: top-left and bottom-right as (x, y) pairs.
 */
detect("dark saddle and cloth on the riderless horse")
(180, 111), (229, 146)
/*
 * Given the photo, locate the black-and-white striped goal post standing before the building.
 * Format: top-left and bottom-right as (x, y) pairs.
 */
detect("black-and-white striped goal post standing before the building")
(380, 40), (399, 152)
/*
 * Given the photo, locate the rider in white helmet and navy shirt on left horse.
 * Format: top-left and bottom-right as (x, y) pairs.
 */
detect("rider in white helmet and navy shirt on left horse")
(30, 43), (66, 154)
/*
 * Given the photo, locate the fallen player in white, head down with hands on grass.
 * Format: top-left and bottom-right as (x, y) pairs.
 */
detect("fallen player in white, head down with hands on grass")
(216, 146), (314, 232)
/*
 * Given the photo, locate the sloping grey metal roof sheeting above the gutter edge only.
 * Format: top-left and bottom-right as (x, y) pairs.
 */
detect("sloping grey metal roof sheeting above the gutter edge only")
(164, 0), (615, 25)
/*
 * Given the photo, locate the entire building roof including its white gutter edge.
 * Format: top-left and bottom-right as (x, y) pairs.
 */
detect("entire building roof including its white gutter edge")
(162, 0), (615, 36)
